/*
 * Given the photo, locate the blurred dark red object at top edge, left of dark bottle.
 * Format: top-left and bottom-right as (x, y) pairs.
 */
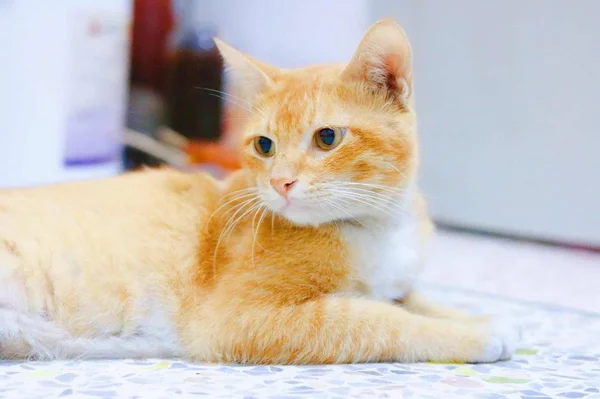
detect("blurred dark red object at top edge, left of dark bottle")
(131, 0), (175, 92)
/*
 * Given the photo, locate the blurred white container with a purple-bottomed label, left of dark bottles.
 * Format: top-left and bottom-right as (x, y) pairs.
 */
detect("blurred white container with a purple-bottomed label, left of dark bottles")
(0, 0), (132, 187)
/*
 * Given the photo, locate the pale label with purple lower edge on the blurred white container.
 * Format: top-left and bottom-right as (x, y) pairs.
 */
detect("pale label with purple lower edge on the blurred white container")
(64, 10), (129, 166)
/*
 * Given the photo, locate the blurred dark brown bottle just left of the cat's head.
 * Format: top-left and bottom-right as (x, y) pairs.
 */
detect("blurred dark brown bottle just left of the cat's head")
(167, 27), (223, 141)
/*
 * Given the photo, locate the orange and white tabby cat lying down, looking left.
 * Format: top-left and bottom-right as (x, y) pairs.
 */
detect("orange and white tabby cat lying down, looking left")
(0, 20), (517, 363)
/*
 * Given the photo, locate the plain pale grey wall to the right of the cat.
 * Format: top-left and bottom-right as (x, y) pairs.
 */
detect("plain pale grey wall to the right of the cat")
(373, 0), (600, 246)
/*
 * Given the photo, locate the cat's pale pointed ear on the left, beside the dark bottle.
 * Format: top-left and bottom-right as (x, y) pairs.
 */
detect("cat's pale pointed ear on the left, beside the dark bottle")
(214, 38), (279, 103)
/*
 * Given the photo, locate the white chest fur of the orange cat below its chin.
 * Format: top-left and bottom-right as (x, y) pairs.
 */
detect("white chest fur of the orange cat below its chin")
(343, 216), (422, 301)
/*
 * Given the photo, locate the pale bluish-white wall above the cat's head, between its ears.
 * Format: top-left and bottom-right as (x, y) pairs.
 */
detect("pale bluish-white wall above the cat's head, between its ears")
(187, 0), (371, 68)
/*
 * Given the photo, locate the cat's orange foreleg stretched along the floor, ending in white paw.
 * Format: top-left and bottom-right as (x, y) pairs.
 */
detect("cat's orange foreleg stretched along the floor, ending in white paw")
(182, 296), (517, 364)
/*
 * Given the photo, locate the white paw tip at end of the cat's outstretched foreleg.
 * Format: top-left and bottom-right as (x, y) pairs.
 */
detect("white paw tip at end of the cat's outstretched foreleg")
(472, 319), (521, 363)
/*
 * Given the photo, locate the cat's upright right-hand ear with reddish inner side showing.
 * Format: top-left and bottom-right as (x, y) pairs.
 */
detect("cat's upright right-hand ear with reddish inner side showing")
(342, 19), (412, 106)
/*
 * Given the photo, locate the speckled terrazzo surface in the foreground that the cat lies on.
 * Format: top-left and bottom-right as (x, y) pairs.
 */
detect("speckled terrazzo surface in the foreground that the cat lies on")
(0, 287), (600, 399)
